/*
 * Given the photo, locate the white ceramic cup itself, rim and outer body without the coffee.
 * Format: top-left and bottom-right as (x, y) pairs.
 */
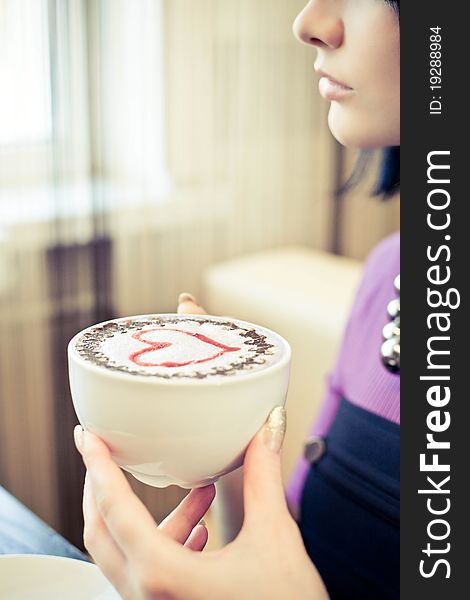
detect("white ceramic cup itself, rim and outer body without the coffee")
(68, 315), (291, 488)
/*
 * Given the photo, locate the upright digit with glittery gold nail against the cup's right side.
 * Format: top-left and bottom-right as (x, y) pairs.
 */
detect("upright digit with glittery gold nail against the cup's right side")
(243, 406), (287, 527)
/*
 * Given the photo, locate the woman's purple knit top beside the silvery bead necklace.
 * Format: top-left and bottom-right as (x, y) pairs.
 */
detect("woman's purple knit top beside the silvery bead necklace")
(287, 232), (400, 512)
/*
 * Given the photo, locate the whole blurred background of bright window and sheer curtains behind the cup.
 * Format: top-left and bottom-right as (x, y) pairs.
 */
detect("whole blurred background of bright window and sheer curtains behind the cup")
(0, 0), (399, 544)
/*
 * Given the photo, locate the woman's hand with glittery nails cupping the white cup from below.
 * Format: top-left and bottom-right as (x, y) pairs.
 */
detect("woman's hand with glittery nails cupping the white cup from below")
(75, 407), (328, 600)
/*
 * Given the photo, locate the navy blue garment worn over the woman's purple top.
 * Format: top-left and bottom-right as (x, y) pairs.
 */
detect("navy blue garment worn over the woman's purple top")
(299, 400), (400, 600)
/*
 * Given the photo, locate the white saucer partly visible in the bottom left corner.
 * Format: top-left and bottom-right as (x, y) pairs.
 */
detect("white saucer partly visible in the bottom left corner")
(0, 554), (120, 600)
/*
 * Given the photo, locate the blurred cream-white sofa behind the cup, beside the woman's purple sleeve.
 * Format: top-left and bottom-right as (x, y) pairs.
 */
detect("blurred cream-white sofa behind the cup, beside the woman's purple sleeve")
(202, 247), (362, 542)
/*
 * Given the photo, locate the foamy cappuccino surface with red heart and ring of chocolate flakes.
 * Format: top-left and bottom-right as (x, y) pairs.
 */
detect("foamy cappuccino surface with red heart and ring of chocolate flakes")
(75, 315), (283, 379)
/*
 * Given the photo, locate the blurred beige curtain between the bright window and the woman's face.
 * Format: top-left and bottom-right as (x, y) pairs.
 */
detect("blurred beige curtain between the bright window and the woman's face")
(110, 0), (335, 314)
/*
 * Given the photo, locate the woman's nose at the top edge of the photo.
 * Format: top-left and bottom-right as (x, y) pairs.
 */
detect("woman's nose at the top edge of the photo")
(293, 0), (344, 48)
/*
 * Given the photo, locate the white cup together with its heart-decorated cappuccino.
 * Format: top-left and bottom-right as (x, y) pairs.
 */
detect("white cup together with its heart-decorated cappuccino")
(68, 314), (290, 488)
